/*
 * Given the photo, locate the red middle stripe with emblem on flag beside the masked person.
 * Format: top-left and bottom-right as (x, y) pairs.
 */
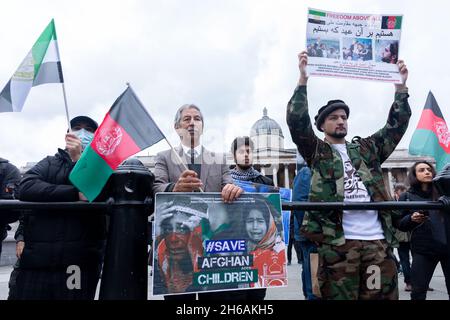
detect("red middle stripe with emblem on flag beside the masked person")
(91, 113), (141, 170)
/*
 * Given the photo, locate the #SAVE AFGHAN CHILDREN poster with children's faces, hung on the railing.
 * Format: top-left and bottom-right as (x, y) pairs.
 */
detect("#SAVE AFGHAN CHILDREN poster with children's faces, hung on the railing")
(152, 192), (287, 295)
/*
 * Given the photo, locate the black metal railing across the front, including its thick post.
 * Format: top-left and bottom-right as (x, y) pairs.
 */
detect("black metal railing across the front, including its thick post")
(0, 196), (450, 300)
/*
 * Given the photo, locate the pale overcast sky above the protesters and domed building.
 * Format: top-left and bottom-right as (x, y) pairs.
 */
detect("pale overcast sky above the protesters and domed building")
(0, 0), (450, 166)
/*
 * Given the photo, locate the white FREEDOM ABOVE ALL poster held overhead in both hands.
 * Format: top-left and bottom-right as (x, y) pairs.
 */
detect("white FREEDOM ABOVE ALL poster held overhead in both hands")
(306, 8), (403, 83)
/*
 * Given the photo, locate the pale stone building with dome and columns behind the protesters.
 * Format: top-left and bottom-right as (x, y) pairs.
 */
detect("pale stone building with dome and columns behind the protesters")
(138, 108), (435, 190)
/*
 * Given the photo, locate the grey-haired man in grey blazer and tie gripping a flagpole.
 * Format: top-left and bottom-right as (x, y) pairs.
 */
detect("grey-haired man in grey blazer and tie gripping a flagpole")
(153, 104), (243, 300)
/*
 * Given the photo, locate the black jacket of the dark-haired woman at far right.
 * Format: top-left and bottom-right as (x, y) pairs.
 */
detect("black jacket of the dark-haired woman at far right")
(398, 188), (446, 255)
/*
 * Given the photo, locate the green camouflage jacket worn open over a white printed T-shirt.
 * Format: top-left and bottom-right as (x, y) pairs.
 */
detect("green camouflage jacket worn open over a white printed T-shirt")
(286, 86), (411, 246)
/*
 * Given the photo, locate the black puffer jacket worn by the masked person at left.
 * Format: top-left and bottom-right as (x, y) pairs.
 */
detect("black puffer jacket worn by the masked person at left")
(19, 149), (106, 268)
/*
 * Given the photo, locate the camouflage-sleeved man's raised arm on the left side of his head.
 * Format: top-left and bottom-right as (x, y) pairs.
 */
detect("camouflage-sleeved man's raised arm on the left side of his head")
(286, 51), (319, 165)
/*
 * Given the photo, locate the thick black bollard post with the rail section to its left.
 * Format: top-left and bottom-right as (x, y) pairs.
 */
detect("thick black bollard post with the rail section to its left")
(0, 159), (154, 300)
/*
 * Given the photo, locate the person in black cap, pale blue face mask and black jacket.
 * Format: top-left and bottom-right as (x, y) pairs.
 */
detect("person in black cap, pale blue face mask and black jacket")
(10, 116), (106, 300)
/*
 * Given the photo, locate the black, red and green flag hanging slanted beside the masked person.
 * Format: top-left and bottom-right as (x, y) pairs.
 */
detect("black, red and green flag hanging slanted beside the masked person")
(69, 87), (165, 201)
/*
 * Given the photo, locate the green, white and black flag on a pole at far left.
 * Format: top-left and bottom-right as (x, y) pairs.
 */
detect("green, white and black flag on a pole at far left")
(0, 19), (64, 112)
